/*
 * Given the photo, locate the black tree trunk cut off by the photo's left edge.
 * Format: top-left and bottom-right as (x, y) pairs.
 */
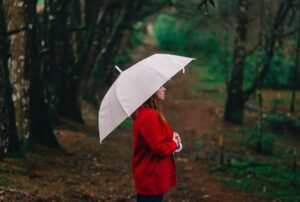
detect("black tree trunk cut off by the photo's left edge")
(0, 0), (19, 160)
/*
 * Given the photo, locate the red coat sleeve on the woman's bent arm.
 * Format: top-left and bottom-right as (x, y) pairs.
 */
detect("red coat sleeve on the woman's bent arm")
(139, 114), (177, 156)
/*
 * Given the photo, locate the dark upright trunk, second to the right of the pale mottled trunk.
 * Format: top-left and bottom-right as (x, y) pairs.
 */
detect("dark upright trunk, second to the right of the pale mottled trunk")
(53, 0), (83, 123)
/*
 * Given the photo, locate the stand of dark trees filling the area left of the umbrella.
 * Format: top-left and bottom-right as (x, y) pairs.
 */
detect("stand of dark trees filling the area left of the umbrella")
(0, 0), (170, 157)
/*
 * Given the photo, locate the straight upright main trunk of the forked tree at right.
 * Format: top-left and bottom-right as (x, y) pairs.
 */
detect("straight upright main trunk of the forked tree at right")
(224, 0), (248, 123)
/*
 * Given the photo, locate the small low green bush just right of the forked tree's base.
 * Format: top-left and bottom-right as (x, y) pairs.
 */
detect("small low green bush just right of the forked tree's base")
(242, 123), (275, 154)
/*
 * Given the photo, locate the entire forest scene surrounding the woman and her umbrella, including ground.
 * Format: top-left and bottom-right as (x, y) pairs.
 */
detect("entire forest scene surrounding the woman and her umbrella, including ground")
(0, 0), (300, 202)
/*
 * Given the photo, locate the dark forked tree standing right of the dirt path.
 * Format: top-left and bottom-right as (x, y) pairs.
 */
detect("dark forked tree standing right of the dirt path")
(224, 0), (294, 123)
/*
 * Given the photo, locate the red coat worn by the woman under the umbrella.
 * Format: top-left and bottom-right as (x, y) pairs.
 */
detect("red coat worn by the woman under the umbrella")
(132, 108), (177, 195)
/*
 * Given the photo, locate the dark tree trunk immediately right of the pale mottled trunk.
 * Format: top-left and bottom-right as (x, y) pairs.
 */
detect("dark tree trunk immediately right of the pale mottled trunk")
(29, 0), (59, 147)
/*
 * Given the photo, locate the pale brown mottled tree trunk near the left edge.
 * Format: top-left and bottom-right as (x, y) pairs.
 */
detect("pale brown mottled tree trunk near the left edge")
(3, 0), (35, 146)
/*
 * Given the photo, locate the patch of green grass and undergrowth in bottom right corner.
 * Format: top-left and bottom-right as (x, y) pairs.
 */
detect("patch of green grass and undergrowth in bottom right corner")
(212, 123), (300, 202)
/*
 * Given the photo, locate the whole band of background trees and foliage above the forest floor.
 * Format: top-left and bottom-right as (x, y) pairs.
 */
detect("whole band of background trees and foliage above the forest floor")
(0, 0), (300, 161)
